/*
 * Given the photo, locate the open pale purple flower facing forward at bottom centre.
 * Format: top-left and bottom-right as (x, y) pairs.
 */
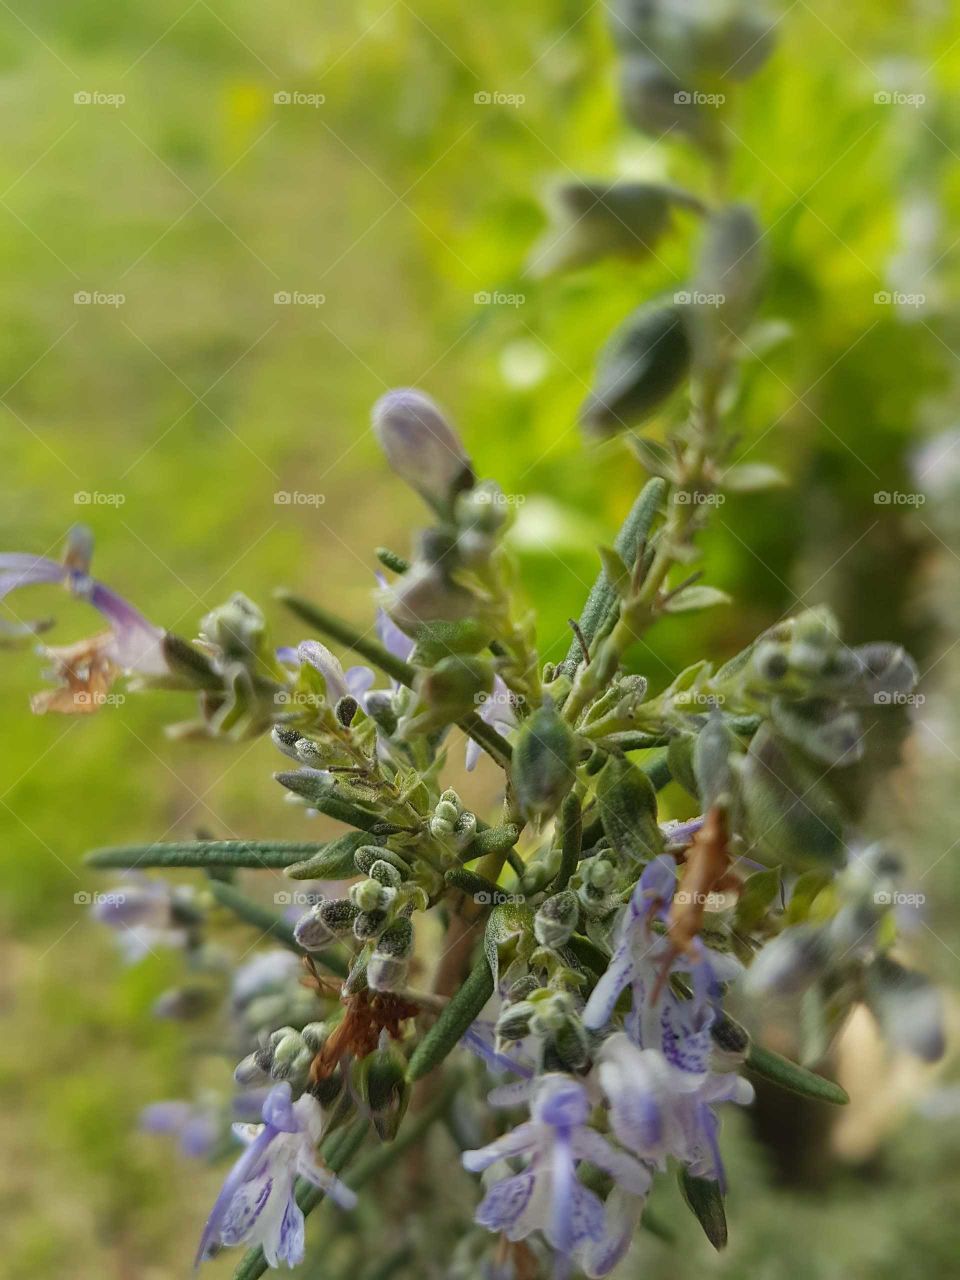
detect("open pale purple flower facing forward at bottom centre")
(462, 1074), (650, 1276)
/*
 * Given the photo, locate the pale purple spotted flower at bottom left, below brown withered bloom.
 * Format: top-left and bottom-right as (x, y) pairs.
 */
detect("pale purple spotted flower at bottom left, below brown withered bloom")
(197, 1082), (356, 1267)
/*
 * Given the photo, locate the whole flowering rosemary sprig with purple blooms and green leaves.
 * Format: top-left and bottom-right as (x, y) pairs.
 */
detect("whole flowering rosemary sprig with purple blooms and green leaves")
(0, 0), (943, 1280)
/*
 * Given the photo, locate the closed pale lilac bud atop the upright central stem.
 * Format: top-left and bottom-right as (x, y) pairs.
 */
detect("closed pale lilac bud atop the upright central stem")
(372, 388), (474, 512)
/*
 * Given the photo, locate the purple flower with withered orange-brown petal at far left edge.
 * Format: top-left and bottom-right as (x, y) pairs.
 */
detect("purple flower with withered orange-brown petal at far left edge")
(0, 527), (168, 714)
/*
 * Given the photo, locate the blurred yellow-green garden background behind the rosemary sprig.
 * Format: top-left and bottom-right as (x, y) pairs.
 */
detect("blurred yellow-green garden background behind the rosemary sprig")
(0, 0), (960, 1280)
